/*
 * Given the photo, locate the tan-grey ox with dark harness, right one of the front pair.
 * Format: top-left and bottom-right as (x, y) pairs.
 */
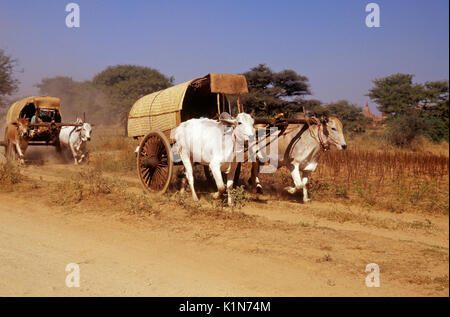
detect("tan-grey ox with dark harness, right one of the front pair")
(250, 117), (347, 203)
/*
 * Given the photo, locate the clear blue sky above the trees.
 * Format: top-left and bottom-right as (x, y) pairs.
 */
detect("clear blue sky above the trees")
(0, 0), (449, 110)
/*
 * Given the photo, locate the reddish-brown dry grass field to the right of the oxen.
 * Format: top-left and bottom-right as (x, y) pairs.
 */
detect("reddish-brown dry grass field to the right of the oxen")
(311, 150), (449, 213)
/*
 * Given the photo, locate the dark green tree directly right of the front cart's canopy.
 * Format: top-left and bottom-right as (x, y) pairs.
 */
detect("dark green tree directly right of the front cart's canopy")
(242, 64), (311, 117)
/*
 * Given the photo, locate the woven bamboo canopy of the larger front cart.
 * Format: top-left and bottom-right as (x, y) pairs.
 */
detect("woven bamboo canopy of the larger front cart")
(128, 73), (248, 137)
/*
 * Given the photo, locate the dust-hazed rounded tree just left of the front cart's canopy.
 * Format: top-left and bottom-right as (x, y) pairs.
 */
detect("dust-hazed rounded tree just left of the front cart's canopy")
(92, 65), (173, 114)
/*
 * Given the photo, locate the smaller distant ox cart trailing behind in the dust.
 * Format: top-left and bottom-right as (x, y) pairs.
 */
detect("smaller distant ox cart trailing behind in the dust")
(0, 96), (81, 160)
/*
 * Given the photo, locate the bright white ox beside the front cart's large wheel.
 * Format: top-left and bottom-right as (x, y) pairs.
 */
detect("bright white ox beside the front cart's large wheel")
(173, 113), (255, 206)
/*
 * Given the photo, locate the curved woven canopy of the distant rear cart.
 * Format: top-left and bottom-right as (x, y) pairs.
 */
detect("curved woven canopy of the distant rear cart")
(6, 96), (61, 123)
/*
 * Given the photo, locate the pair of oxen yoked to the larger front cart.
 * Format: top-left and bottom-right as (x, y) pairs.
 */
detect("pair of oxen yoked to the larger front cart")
(172, 113), (347, 206)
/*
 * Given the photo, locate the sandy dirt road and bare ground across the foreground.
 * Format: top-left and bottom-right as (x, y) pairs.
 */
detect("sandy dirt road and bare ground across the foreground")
(0, 147), (449, 296)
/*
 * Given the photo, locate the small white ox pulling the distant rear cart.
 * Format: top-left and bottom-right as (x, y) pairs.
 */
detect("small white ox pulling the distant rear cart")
(59, 118), (92, 165)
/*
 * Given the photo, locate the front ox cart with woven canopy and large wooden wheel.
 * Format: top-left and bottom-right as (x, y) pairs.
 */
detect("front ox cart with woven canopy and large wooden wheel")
(127, 73), (315, 194)
